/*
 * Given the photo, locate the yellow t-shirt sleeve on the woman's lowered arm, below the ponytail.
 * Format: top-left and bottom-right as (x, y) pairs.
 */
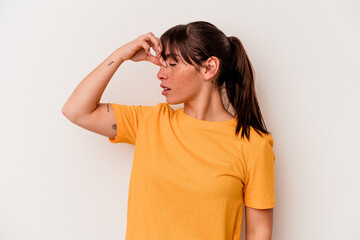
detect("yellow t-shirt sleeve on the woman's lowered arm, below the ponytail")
(243, 134), (275, 209)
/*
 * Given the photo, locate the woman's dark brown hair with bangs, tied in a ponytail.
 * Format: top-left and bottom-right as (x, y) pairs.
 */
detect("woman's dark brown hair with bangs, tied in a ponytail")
(160, 21), (269, 140)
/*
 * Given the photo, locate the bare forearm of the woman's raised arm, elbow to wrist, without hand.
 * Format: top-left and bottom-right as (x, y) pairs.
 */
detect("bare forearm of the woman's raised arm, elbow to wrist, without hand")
(62, 48), (124, 120)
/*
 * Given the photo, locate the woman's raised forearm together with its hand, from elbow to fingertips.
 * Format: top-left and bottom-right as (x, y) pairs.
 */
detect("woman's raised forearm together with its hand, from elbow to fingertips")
(62, 32), (165, 122)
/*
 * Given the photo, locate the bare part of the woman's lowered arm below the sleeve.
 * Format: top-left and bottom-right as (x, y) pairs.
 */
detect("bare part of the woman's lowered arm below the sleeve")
(245, 206), (273, 240)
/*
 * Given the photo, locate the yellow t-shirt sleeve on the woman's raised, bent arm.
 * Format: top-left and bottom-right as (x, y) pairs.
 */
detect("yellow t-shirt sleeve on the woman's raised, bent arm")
(108, 103), (155, 145)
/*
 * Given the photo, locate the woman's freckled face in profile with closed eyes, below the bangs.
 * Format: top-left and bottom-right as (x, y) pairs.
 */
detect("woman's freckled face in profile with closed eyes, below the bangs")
(157, 51), (203, 104)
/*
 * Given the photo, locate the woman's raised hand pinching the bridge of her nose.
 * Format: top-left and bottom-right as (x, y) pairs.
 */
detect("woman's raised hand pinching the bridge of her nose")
(120, 32), (166, 67)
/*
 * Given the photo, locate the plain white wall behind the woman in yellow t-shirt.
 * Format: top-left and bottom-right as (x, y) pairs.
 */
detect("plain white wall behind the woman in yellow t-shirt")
(0, 0), (360, 240)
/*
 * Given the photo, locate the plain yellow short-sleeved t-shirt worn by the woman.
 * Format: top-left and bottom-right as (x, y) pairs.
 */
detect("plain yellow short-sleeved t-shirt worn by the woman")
(109, 103), (275, 240)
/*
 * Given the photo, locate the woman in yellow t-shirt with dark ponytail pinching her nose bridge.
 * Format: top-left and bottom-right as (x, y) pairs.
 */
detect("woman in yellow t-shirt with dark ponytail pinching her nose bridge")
(63, 21), (275, 240)
